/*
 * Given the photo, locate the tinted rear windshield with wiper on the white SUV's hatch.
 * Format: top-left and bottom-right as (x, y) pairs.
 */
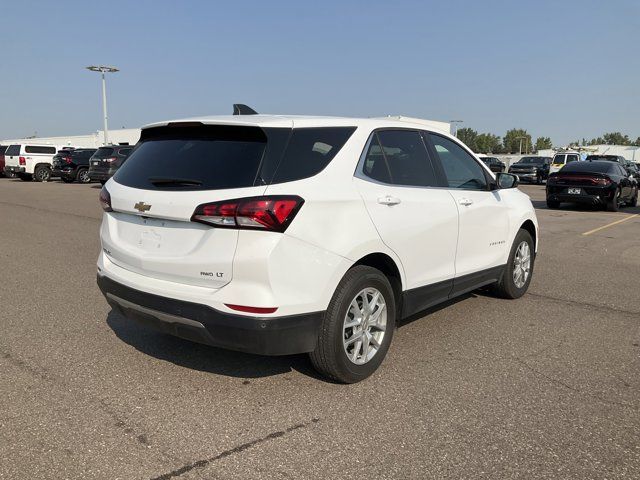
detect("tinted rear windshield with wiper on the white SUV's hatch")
(114, 126), (267, 190)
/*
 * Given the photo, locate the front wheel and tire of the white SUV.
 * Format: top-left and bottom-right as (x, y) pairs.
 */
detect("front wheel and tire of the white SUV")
(493, 228), (535, 299)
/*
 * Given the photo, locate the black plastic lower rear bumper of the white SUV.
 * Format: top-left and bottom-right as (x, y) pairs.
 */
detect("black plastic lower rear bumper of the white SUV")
(98, 274), (324, 355)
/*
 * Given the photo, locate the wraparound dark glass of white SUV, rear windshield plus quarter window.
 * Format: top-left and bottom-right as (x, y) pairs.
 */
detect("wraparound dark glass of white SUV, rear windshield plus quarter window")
(114, 125), (355, 190)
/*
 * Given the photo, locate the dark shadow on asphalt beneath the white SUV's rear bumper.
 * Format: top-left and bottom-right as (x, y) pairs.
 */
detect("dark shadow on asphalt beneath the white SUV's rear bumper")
(107, 310), (326, 381)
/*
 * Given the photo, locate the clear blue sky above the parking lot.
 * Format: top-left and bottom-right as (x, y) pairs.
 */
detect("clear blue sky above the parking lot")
(0, 0), (640, 144)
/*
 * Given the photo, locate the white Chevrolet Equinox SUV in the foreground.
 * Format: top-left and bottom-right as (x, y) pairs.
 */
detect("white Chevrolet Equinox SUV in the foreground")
(98, 111), (538, 383)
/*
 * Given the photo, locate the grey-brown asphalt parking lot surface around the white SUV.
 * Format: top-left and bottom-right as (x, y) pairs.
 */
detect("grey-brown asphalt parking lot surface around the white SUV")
(0, 179), (640, 479)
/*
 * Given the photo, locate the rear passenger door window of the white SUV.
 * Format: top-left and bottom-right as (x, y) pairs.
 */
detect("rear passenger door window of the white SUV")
(363, 130), (436, 187)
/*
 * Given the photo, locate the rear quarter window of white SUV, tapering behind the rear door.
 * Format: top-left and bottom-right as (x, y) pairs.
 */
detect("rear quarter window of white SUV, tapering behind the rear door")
(272, 127), (355, 183)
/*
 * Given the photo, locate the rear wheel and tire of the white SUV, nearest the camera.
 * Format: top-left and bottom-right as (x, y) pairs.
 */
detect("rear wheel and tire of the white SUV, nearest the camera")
(309, 265), (396, 383)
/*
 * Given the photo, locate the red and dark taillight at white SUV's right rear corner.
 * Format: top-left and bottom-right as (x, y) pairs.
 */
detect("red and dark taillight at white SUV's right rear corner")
(191, 195), (304, 232)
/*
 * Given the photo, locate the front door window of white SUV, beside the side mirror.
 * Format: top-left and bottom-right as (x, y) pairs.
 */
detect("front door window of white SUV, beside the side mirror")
(428, 133), (487, 190)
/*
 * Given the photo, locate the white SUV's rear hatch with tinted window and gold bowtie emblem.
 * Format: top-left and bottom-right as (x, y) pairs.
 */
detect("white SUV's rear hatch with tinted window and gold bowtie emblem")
(102, 125), (278, 288)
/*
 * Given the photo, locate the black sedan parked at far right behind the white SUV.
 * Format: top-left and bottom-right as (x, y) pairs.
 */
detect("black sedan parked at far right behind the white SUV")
(547, 160), (638, 212)
